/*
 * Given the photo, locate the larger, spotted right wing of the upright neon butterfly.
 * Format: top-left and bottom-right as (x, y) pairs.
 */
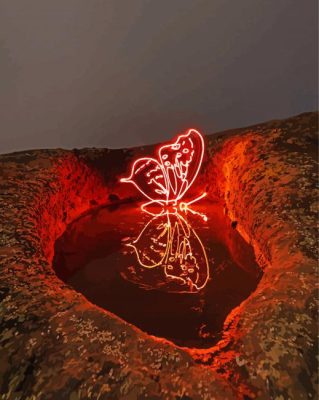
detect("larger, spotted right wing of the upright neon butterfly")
(158, 129), (204, 201)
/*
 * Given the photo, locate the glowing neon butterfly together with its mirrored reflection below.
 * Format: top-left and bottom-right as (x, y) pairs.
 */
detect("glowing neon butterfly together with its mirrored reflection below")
(121, 129), (209, 292)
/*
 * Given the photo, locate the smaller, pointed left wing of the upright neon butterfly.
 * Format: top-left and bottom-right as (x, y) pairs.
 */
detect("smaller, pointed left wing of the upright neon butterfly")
(121, 157), (168, 202)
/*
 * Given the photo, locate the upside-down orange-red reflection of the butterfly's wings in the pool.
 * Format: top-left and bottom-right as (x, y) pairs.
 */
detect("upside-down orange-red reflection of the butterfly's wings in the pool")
(128, 212), (209, 293)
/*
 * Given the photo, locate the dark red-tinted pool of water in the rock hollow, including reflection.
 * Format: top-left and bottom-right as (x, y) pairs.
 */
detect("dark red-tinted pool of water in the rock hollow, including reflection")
(53, 202), (261, 347)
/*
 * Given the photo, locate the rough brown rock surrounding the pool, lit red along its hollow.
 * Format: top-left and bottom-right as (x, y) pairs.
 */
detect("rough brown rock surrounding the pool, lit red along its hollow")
(0, 113), (318, 400)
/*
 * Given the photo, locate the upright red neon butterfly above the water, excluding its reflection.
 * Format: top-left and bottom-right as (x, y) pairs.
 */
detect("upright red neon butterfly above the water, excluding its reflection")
(121, 129), (206, 219)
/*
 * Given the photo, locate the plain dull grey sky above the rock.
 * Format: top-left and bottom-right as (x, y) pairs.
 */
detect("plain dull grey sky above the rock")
(0, 0), (317, 153)
